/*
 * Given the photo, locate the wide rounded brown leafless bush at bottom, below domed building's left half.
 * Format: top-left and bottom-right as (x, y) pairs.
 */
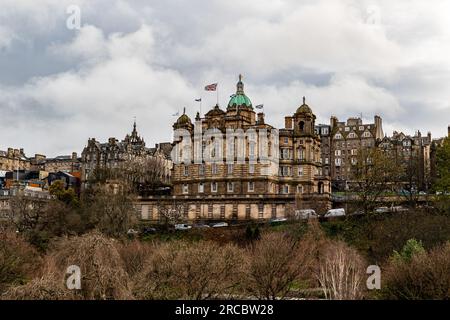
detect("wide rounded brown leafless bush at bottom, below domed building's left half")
(134, 241), (244, 300)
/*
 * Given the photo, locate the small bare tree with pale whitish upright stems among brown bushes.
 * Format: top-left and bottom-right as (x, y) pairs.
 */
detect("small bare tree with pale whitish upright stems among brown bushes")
(317, 242), (364, 300)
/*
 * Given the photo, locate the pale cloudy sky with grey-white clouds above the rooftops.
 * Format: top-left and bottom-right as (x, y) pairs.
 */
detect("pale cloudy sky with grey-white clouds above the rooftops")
(0, 0), (450, 156)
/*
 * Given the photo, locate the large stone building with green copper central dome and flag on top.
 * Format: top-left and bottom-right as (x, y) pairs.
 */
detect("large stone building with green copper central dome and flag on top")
(140, 77), (331, 220)
